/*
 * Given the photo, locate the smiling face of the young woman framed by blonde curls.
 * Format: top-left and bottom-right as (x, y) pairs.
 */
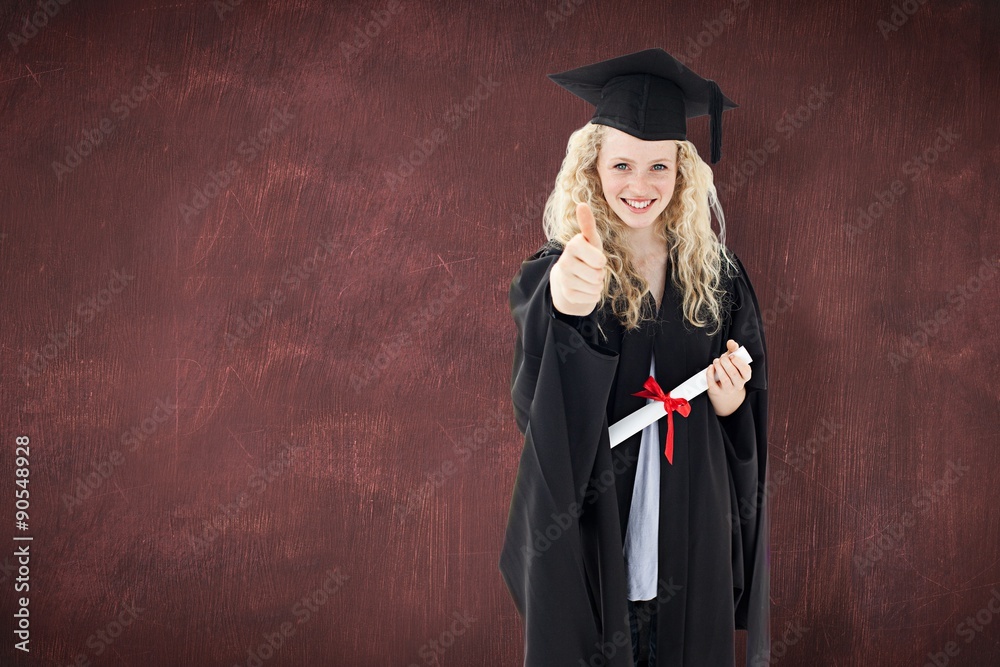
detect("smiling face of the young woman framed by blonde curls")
(597, 127), (677, 235)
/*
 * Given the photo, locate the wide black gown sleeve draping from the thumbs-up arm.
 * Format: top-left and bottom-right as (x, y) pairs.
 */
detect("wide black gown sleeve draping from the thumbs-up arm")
(499, 243), (631, 667)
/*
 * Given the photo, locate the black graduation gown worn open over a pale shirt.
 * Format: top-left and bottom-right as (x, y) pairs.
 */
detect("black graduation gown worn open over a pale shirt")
(499, 241), (770, 667)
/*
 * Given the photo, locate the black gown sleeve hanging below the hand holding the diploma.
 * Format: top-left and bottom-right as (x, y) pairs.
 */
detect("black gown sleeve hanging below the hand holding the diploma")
(719, 254), (771, 665)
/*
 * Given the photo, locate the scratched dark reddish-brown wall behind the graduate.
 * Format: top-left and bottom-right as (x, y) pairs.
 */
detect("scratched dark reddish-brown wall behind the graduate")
(0, 0), (1000, 667)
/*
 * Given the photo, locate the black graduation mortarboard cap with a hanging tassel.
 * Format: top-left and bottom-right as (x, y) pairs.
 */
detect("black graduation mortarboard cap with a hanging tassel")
(549, 49), (739, 164)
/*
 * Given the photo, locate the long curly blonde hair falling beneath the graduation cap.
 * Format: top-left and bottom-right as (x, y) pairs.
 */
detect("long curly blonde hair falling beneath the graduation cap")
(542, 123), (738, 335)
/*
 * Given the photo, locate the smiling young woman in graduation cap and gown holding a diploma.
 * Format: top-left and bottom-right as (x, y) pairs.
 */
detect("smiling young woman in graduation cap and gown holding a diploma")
(500, 49), (769, 667)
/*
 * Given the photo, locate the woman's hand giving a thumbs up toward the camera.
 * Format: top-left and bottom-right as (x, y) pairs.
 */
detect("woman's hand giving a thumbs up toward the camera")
(549, 204), (608, 316)
